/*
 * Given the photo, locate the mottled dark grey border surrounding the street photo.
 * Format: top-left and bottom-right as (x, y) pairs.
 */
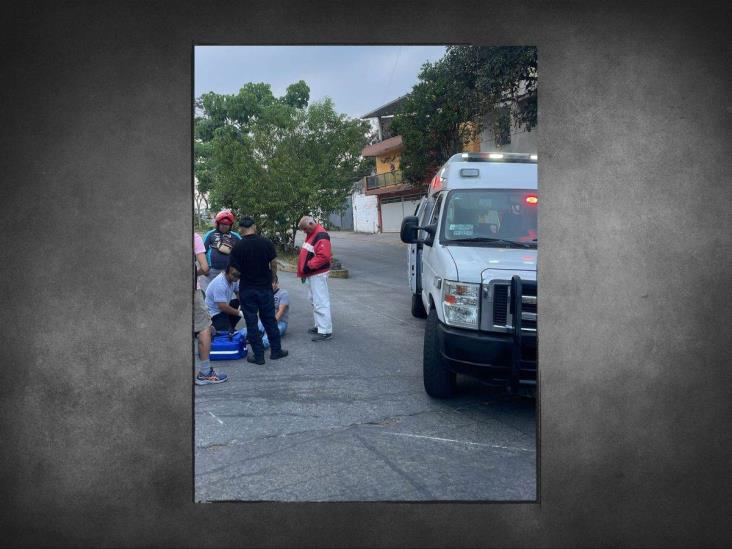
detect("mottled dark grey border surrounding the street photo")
(0, 0), (732, 547)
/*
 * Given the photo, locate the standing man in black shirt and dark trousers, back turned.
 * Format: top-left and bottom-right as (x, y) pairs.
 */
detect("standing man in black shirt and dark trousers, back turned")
(229, 216), (287, 364)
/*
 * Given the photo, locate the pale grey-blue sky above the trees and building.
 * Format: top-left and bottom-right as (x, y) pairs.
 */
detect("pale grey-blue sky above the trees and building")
(194, 46), (445, 118)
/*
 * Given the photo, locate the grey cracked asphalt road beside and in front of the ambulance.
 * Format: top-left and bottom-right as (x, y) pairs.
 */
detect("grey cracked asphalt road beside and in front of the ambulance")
(195, 232), (536, 501)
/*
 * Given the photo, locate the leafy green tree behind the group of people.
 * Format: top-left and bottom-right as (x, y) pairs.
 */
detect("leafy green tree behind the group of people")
(194, 80), (369, 245)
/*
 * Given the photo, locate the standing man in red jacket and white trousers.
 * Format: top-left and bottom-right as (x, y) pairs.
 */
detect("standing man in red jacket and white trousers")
(297, 215), (333, 341)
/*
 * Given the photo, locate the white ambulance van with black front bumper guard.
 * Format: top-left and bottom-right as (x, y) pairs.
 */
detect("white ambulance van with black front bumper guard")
(400, 152), (539, 398)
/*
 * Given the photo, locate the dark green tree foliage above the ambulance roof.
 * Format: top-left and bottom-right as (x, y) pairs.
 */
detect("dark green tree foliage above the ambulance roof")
(391, 46), (537, 184)
